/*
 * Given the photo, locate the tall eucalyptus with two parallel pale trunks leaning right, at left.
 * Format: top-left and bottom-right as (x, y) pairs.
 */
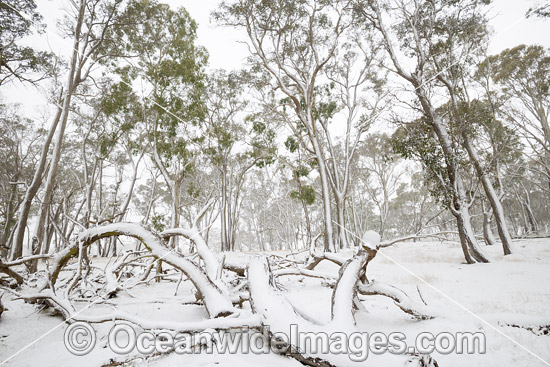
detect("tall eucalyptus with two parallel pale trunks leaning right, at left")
(10, 0), (122, 258)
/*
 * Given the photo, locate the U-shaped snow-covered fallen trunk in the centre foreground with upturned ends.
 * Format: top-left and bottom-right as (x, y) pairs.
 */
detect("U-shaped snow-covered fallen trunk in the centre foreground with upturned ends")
(248, 251), (437, 367)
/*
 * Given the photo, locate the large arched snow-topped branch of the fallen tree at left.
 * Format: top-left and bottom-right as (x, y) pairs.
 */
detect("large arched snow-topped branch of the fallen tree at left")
(50, 223), (239, 317)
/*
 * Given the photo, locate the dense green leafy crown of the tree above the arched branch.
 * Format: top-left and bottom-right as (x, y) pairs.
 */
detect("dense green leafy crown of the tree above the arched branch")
(102, 0), (207, 171)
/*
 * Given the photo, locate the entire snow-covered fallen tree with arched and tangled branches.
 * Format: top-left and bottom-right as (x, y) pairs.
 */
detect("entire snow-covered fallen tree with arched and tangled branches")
(3, 223), (436, 367)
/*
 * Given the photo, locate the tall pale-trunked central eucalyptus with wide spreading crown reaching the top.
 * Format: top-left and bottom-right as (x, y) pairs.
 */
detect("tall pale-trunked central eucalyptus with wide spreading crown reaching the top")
(218, 0), (382, 250)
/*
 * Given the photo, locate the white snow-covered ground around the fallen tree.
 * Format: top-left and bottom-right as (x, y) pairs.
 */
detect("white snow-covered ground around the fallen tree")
(0, 239), (550, 367)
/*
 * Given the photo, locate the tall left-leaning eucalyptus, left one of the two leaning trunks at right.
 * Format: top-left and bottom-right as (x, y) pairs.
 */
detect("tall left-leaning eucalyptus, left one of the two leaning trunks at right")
(355, 0), (489, 263)
